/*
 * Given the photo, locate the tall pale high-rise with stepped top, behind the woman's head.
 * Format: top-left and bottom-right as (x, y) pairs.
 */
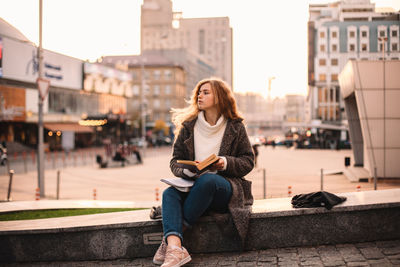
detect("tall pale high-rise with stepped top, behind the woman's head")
(140, 0), (233, 95)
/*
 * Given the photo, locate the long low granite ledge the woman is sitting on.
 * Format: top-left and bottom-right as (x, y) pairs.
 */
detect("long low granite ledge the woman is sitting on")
(0, 189), (400, 263)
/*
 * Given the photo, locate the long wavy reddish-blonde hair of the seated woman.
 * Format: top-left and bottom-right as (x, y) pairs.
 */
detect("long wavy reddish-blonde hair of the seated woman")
(171, 77), (243, 138)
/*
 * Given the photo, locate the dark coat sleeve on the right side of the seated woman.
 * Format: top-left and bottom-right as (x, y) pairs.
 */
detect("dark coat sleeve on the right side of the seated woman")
(220, 123), (254, 178)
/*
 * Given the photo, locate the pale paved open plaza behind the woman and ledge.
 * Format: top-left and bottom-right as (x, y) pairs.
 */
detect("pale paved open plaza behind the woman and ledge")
(0, 147), (400, 201)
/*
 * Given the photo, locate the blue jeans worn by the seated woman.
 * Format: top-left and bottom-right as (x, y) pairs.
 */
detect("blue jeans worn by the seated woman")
(162, 173), (232, 243)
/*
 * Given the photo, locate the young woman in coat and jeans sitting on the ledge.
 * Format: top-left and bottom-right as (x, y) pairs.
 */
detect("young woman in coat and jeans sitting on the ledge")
(153, 78), (254, 267)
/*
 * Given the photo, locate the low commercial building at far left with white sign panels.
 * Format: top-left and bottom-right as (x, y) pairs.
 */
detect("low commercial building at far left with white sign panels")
(0, 19), (136, 150)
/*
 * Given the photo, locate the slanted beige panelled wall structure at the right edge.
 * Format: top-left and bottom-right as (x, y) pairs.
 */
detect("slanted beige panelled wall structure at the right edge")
(339, 60), (400, 178)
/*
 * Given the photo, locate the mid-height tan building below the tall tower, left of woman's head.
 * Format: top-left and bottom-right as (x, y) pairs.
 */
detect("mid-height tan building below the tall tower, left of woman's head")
(100, 53), (187, 126)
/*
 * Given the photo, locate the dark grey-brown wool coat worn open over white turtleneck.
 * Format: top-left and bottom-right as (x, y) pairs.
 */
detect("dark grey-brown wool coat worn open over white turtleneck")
(170, 118), (254, 245)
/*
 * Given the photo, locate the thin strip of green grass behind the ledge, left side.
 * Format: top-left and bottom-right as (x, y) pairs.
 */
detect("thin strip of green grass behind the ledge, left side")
(0, 208), (140, 221)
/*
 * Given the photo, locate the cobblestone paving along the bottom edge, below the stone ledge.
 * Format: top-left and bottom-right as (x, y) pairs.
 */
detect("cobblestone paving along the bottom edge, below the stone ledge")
(10, 240), (400, 267)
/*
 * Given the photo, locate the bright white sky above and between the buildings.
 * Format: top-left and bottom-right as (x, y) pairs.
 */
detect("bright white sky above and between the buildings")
(0, 0), (400, 97)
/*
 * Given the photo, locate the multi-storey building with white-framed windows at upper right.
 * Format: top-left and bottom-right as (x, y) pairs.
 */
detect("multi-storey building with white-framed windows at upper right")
(307, 0), (400, 125)
